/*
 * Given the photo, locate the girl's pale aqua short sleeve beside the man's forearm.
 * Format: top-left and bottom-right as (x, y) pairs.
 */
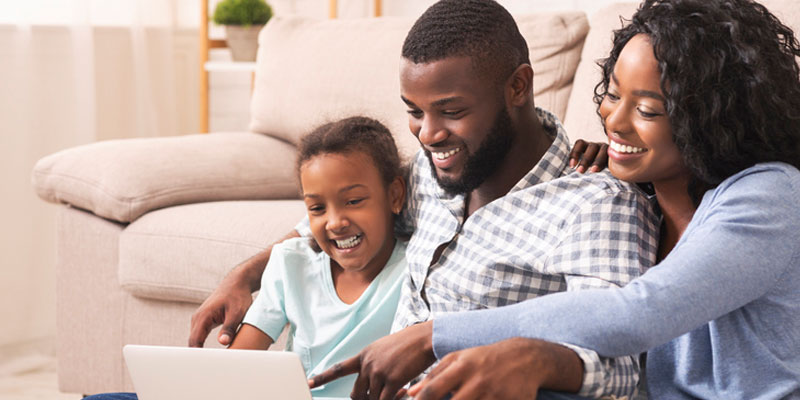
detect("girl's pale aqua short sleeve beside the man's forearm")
(242, 244), (288, 341)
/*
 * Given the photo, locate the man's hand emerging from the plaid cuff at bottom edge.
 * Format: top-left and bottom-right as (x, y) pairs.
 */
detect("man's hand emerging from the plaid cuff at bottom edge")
(408, 338), (583, 400)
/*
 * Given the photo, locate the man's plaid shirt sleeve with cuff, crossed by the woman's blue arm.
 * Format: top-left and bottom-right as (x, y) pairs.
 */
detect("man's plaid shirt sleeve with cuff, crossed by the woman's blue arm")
(546, 187), (658, 398)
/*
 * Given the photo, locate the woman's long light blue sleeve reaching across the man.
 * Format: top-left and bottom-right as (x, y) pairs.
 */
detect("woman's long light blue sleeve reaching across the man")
(433, 165), (800, 388)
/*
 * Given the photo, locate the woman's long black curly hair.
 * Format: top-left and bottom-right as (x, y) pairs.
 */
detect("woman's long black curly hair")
(594, 0), (800, 202)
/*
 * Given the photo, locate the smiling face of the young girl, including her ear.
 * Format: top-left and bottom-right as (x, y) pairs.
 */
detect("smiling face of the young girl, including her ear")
(300, 151), (405, 272)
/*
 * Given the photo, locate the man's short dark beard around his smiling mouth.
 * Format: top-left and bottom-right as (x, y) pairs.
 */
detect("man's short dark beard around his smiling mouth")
(425, 107), (513, 195)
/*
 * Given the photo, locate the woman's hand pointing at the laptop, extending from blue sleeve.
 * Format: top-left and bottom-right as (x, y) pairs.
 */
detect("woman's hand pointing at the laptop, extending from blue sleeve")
(308, 321), (436, 400)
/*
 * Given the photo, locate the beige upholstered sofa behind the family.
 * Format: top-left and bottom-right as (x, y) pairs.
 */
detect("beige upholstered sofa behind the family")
(33, 0), (800, 394)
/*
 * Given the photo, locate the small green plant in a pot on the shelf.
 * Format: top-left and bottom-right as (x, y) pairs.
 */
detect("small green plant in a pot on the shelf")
(213, 0), (272, 61)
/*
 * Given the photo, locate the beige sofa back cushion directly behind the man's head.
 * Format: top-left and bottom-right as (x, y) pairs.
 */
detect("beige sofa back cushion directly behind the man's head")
(250, 12), (588, 156)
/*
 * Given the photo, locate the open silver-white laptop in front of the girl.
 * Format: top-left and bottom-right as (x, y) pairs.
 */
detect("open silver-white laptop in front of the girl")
(122, 345), (338, 400)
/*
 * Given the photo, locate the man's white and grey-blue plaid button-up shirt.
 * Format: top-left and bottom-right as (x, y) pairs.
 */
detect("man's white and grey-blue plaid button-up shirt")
(393, 109), (658, 397)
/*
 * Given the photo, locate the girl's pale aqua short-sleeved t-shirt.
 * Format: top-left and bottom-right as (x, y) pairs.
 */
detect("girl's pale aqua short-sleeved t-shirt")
(244, 238), (408, 397)
